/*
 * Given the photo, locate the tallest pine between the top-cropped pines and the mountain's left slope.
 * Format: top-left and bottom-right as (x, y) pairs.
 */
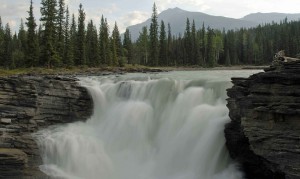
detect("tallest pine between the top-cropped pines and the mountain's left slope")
(76, 4), (86, 65)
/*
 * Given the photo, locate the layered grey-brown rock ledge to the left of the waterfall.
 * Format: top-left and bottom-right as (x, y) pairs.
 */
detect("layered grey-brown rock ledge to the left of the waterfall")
(0, 76), (93, 178)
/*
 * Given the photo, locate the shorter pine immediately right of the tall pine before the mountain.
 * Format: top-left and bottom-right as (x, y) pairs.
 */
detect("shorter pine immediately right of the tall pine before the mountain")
(159, 21), (168, 66)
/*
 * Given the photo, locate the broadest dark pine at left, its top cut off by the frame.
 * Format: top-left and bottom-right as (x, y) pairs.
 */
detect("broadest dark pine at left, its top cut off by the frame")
(40, 0), (61, 68)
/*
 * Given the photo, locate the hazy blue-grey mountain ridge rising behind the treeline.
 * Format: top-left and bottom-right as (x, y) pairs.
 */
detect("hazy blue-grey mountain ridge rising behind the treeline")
(128, 7), (300, 41)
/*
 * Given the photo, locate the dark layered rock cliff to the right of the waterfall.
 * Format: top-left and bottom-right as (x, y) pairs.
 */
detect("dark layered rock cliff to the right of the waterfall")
(225, 62), (300, 179)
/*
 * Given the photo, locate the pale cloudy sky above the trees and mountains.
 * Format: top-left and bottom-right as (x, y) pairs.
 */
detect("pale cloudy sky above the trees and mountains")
(0, 0), (300, 32)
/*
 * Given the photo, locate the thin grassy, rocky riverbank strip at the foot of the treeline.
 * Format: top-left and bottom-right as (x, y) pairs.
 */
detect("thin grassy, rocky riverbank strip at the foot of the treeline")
(0, 65), (267, 77)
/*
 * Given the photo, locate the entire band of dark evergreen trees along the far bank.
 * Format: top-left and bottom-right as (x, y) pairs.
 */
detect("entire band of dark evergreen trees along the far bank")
(0, 0), (300, 69)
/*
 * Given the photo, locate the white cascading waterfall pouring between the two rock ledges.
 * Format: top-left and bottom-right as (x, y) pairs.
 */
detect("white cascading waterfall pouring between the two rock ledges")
(36, 71), (260, 179)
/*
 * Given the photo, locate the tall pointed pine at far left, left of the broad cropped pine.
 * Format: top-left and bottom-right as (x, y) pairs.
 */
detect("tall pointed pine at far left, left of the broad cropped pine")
(25, 0), (38, 67)
